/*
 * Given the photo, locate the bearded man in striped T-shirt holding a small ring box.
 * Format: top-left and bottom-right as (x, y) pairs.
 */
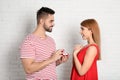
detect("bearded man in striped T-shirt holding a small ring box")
(20, 7), (68, 80)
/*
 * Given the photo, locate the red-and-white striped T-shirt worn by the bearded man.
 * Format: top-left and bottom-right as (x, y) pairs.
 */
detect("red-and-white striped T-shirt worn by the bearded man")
(20, 34), (57, 80)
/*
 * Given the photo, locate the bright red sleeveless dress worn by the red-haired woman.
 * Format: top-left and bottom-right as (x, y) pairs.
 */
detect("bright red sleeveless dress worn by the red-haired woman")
(71, 44), (99, 80)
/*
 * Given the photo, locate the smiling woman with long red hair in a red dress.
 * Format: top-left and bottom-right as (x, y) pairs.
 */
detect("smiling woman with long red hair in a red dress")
(71, 19), (100, 80)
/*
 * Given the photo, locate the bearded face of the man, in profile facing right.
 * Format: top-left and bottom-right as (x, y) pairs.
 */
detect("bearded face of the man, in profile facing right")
(43, 14), (54, 32)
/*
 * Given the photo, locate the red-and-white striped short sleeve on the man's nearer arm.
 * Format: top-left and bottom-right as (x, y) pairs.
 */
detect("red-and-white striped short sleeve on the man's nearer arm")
(20, 39), (35, 59)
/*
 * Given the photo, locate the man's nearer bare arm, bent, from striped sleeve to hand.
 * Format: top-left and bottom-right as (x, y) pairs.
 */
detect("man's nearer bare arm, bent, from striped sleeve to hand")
(22, 50), (62, 74)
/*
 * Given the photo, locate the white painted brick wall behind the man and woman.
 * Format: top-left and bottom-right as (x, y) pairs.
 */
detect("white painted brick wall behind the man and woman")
(0, 0), (120, 80)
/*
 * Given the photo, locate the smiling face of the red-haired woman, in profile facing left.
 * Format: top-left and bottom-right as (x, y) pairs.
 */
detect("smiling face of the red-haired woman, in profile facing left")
(80, 26), (91, 40)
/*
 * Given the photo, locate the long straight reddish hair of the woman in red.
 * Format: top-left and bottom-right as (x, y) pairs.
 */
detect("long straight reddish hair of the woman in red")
(81, 19), (101, 60)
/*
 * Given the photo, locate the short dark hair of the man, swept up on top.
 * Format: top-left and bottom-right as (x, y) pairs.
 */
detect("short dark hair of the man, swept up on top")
(37, 7), (55, 24)
